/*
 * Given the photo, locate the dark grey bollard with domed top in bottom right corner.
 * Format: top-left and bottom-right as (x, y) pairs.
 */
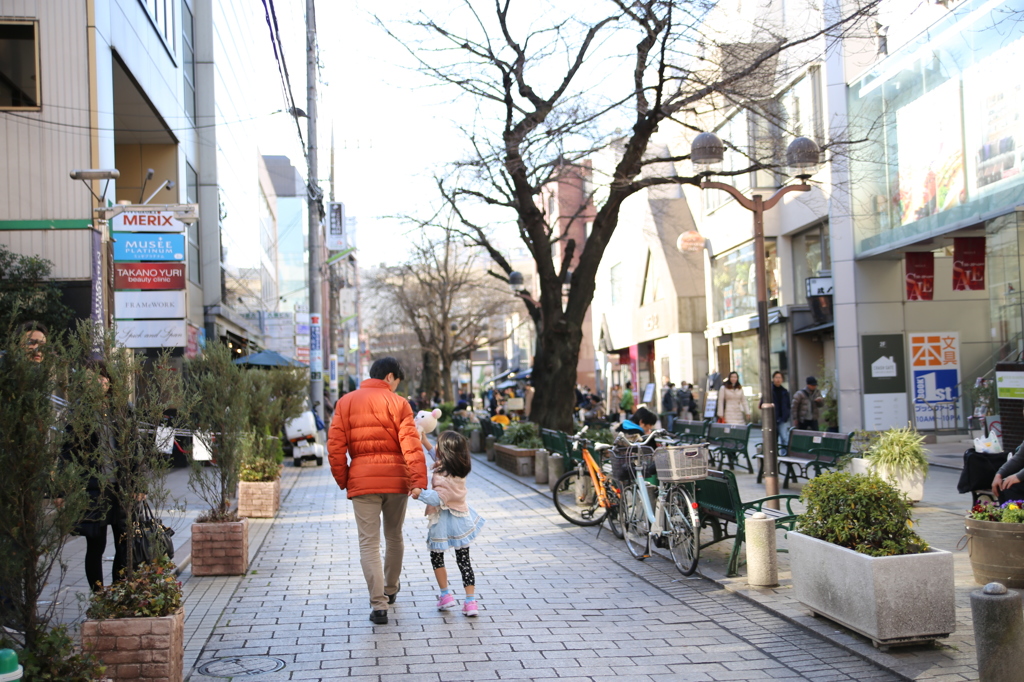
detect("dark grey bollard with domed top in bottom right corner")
(971, 583), (1024, 682)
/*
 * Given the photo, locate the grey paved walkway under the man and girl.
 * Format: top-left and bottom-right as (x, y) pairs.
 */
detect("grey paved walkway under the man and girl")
(186, 462), (899, 682)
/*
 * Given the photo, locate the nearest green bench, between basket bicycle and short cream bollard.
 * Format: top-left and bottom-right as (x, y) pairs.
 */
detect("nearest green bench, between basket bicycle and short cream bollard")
(696, 470), (800, 578)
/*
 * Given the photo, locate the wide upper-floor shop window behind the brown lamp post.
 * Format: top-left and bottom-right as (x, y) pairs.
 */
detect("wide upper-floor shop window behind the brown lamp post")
(712, 239), (779, 322)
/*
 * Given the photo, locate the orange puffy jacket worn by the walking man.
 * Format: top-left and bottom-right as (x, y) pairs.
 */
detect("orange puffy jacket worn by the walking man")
(327, 379), (427, 498)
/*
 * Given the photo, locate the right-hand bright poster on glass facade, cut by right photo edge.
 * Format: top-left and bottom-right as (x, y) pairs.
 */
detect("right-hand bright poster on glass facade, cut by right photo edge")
(964, 40), (1024, 199)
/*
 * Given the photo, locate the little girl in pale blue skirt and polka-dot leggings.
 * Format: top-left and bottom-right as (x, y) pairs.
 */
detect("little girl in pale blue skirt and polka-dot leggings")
(410, 431), (484, 616)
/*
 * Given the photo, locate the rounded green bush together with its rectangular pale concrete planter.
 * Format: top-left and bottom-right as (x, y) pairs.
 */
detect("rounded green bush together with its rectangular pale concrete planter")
(787, 471), (956, 648)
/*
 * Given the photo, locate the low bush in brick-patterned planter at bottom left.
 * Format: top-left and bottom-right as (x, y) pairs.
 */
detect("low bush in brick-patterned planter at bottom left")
(82, 557), (185, 682)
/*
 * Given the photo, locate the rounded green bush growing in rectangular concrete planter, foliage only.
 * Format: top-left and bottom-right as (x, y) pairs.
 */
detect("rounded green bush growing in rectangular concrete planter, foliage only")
(797, 471), (928, 556)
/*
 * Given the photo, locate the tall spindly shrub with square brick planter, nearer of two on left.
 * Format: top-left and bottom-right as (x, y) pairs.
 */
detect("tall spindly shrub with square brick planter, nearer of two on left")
(185, 343), (253, 576)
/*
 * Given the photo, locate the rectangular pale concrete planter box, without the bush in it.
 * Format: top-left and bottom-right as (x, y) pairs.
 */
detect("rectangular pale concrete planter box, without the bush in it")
(786, 531), (956, 650)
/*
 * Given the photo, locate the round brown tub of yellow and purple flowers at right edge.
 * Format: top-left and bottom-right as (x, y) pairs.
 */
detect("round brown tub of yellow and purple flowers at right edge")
(965, 500), (1024, 589)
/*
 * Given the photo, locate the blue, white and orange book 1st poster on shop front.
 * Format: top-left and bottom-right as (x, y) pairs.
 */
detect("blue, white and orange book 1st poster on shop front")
(907, 332), (961, 430)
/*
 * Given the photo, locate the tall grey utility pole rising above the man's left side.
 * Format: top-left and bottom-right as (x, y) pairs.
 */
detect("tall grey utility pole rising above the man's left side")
(306, 0), (325, 419)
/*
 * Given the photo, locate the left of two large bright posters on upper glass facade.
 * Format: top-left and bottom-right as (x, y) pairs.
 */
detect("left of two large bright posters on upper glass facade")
(896, 79), (966, 225)
